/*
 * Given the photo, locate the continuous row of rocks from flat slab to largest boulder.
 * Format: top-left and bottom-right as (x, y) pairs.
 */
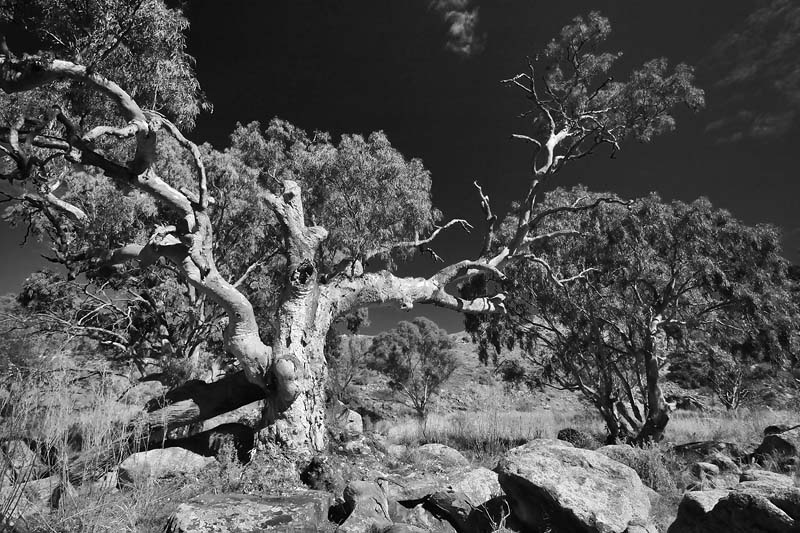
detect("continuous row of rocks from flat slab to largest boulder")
(167, 439), (657, 533)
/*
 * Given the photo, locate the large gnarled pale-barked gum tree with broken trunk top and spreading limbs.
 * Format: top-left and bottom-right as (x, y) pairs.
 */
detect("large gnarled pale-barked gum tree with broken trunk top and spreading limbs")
(0, 6), (702, 449)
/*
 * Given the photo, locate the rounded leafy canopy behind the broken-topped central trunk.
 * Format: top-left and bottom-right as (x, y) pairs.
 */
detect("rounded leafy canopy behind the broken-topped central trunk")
(226, 119), (441, 268)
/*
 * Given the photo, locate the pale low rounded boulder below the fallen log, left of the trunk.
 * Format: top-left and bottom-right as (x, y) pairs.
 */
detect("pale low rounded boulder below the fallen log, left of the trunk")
(118, 448), (216, 485)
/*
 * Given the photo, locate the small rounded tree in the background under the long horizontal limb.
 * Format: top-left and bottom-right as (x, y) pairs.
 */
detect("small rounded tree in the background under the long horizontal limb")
(368, 317), (456, 420)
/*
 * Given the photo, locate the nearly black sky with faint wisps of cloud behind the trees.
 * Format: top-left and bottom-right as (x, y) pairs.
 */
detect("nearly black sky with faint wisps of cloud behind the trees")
(0, 0), (800, 331)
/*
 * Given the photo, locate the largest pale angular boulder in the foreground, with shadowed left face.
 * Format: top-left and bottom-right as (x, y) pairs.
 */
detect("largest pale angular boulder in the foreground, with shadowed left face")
(496, 440), (655, 533)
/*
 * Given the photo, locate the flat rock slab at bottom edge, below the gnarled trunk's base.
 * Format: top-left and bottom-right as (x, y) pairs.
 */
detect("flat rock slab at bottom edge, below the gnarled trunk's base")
(164, 490), (334, 533)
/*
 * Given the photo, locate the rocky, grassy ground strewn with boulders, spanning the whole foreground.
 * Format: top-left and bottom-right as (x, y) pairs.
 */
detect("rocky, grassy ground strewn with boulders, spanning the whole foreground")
(0, 335), (800, 533)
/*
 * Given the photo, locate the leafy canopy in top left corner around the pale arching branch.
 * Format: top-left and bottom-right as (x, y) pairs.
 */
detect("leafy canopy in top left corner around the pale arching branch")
(0, 0), (207, 128)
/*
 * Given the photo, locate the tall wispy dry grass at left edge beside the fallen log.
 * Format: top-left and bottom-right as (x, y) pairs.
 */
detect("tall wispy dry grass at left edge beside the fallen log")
(0, 368), (188, 532)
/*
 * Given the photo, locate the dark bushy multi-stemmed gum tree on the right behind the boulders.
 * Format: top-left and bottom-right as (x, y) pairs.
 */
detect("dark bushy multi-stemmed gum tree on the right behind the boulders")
(484, 189), (798, 444)
